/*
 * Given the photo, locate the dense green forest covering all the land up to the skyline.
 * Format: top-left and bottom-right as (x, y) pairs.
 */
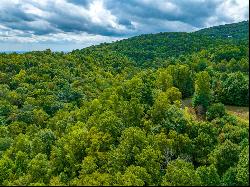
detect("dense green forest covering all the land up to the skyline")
(0, 21), (249, 186)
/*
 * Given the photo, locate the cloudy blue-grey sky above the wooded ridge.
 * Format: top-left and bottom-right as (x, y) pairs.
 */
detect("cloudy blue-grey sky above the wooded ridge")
(0, 0), (249, 51)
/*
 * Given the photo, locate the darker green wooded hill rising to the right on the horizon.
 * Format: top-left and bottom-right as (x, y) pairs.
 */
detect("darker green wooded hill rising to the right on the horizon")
(73, 21), (249, 66)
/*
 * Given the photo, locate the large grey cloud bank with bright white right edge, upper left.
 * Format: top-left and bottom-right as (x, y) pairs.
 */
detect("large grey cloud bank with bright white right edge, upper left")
(0, 0), (135, 36)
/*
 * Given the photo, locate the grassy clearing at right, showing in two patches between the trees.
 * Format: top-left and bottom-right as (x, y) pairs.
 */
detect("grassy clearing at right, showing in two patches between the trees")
(182, 98), (249, 123)
